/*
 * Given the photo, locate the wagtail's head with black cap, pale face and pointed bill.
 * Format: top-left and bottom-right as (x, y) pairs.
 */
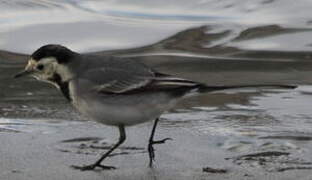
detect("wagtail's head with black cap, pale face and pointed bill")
(14, 44), (76, 81)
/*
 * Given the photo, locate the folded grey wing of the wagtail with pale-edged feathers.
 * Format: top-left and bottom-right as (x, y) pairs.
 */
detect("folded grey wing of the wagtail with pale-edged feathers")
(80, 60), (198, 94)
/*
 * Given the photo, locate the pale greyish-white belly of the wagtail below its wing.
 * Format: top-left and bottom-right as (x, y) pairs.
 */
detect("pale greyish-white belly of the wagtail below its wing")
(72, 82), (175, 126)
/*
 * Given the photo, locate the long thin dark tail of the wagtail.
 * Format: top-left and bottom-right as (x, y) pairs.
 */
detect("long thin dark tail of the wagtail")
(197, 84), (297, 93)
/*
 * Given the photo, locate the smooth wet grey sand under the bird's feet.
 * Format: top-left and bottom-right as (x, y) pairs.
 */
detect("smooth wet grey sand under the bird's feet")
(0, 113), (312, 180)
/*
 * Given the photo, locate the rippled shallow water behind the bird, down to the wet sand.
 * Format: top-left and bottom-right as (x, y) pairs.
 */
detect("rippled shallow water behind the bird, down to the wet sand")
(0, 0), (312, 174)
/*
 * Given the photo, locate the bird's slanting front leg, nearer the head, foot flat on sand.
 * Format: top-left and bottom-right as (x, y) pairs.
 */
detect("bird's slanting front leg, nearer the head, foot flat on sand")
(72, 126), (126, 171)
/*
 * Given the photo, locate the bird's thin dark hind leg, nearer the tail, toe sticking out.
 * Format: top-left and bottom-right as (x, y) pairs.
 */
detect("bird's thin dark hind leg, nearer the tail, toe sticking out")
(147, 118), (172, 167)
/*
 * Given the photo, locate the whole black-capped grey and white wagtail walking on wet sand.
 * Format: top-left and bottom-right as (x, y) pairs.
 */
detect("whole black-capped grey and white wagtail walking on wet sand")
(15, 44), (294, 170)
